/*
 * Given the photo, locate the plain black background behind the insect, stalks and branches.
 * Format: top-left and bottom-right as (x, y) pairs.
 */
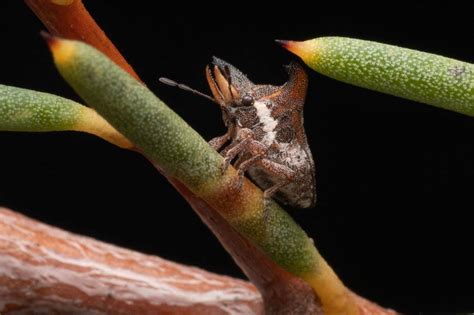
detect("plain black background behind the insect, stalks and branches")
(0, 1), (474, 312)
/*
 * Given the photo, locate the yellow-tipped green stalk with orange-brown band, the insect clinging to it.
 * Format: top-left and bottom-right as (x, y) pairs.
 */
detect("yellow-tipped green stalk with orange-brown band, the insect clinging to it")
(48, 38), (357, 314)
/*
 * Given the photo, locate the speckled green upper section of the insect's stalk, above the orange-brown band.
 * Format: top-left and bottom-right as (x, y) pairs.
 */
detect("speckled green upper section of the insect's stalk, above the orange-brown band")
(57, 41), (222, 189)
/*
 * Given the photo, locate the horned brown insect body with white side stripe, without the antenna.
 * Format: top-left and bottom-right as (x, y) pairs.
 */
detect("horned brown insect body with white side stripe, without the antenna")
(206, 58), (316, 208)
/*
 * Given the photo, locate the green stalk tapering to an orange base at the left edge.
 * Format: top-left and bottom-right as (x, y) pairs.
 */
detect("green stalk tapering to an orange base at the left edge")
(0, 84), (133, 148)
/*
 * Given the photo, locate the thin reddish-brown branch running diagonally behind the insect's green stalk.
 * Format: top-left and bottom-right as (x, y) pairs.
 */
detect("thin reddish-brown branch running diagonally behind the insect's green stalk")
(23, 0), (395, 314)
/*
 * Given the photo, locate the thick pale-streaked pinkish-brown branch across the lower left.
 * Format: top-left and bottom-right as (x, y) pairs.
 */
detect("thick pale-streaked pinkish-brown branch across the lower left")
(0, 208), (263, 314)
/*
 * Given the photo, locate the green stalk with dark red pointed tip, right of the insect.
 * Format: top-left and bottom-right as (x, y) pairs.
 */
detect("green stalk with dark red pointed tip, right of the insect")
(279, 37), (474, 116)
